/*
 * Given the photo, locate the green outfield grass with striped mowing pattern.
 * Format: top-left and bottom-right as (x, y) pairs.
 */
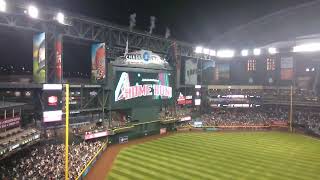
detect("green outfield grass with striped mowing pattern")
(108, 132), (320, 180)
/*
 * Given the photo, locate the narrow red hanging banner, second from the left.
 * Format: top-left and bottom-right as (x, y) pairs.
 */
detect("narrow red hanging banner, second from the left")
(55, 34), (63, 83)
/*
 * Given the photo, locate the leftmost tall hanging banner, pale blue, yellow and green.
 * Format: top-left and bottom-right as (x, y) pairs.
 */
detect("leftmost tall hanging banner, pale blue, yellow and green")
(33, 32), (46, 83)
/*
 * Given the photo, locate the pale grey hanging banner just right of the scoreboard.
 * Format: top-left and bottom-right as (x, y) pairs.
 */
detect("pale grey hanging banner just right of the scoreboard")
(184, 59), (198, 85)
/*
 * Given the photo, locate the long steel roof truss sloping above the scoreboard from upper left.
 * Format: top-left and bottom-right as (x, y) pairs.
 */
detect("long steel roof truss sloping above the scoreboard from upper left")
(0, 0), (196, 59)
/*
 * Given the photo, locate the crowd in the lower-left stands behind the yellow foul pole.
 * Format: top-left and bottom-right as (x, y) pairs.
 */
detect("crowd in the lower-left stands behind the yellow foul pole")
(0, 140), (103, 180)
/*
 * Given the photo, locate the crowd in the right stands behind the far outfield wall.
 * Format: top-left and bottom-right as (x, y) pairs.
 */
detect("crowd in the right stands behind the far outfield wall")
(196, 107), (320, 135)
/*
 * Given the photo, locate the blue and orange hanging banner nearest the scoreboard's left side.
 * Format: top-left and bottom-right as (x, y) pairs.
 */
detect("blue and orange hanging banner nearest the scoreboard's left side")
(91, 43), (106, 83)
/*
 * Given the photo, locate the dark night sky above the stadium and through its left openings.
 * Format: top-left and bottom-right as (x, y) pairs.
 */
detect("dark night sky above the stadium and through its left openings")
(0, 0), (311, 74)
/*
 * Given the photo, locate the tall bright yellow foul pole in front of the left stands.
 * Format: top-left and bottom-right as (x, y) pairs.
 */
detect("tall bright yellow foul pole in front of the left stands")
(65, 84), (69, 180)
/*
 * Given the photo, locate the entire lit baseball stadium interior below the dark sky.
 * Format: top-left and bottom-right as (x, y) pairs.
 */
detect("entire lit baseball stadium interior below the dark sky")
(0, 0), (320, 180)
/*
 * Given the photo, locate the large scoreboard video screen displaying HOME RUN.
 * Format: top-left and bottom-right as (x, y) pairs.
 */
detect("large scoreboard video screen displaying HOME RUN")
(114, 71), (173, 108)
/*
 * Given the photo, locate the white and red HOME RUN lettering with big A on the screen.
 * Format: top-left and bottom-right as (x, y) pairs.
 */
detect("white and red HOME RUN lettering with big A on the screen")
(115, 72), (172, 102)
